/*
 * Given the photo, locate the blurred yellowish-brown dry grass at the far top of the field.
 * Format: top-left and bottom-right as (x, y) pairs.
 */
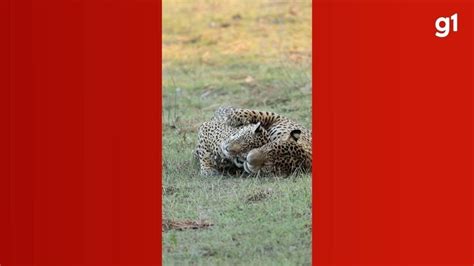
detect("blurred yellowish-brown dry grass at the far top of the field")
(163, 0), (311, 68)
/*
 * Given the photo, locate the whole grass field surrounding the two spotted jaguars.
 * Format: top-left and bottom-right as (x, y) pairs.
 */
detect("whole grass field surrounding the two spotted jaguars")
(162, 0), (312, 265)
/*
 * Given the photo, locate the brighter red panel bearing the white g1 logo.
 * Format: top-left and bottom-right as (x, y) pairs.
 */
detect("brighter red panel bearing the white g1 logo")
(313, 0), (474, 265)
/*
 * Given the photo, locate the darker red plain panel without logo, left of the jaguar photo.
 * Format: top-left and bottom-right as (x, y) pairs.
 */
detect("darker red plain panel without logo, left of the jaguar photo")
(0, 0), (161, 266)
